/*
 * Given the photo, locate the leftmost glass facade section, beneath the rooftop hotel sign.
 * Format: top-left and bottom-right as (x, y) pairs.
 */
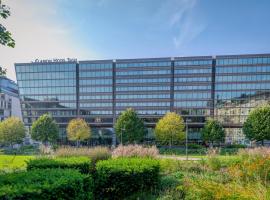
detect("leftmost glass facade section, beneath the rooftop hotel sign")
(15, 63), (77, 138)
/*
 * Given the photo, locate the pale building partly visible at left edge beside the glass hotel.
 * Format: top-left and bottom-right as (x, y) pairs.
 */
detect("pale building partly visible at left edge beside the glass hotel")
(0, 76), (22, 121)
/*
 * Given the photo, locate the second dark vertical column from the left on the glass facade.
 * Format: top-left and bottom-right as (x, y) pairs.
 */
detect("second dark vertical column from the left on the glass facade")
(112, 60), (116, 147)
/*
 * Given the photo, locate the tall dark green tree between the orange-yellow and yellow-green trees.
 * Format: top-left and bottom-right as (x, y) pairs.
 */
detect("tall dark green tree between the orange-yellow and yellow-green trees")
(114, 108), (147, 144)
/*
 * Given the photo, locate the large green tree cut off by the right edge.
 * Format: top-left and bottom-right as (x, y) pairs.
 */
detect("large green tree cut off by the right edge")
(243, 105), (270, 145)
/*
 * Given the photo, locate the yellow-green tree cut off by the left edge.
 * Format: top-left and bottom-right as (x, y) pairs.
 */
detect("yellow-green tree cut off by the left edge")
(0, 117), (25, 145)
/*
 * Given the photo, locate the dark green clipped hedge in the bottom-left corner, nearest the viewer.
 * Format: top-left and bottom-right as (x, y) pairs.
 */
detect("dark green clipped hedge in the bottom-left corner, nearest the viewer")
(0, 169), (93, 200)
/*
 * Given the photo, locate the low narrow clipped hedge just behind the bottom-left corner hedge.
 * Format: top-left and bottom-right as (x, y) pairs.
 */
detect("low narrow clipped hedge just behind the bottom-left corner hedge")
(27, 157), (91, 174)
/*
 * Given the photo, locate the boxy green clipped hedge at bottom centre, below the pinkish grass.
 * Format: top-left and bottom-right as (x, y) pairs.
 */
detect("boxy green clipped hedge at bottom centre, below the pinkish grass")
(95, 158), (160, 199)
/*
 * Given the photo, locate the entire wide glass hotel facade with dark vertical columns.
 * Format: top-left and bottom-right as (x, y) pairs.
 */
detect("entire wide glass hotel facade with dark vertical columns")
(15, 54), (270, 143)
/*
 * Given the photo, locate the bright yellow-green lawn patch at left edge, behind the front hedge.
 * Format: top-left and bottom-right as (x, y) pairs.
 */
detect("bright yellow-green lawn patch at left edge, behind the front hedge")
(0, 155), (33, 171)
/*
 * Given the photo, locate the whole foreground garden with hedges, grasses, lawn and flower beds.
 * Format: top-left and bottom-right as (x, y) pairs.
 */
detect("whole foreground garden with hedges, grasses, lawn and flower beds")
(0, 145), (270, 200)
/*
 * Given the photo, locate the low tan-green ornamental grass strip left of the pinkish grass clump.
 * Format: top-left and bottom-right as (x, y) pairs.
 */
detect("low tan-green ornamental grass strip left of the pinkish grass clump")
(55, 146), (111, 164)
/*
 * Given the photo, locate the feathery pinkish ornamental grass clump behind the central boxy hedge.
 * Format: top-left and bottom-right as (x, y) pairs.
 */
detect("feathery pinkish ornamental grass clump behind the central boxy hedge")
(112, 144), (159, 158)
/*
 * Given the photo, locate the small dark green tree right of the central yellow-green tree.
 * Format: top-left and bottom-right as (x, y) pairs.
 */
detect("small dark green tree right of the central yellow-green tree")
(202, 119), (225, 145)
